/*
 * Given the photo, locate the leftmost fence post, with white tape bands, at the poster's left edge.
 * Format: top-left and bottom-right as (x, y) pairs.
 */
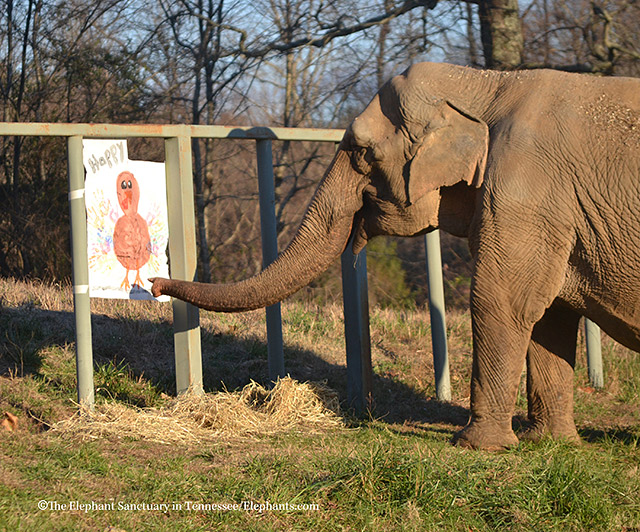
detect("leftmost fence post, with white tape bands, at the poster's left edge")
(67, 136), (95, 408)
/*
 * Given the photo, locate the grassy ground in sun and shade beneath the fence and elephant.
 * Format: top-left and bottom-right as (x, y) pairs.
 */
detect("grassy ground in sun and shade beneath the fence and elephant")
(0, 280), (640, 532)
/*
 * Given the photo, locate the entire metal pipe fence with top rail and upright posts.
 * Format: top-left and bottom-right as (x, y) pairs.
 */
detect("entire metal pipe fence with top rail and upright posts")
(0, 122), (603, 412)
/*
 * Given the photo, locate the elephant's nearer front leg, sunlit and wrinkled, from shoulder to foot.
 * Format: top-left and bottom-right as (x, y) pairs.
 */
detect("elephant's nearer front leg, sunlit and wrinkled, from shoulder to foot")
(456, 180), (573, 449)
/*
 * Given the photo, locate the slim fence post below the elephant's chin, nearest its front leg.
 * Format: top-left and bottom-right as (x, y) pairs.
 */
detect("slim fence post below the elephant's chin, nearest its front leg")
(425, 230), (451, 401)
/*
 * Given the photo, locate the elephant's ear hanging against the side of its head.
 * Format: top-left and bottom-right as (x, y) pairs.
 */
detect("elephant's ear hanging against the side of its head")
(407, 102), (489, 205)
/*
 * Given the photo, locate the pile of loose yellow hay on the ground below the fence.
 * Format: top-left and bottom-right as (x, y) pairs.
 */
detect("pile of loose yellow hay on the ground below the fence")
(53, 377), (343, 444)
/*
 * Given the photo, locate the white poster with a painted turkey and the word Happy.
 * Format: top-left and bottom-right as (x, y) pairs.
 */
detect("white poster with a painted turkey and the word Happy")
(83, 139), (169, 301)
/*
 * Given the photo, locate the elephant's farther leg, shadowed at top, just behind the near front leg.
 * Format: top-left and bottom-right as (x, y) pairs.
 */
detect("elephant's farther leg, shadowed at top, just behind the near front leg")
(520, 304), (580, 441)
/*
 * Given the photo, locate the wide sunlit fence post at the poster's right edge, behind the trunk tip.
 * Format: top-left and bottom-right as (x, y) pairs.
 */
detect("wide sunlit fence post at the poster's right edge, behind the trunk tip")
(165, 135), (203, 394)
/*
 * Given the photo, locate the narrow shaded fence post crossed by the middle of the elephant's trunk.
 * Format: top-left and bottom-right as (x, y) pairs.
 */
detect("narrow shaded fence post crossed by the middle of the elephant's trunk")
(256, 140), (285, 382)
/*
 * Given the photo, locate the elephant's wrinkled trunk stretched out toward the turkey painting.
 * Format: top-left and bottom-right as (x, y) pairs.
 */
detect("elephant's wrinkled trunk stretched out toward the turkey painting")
(151, 149), (362, 312)
